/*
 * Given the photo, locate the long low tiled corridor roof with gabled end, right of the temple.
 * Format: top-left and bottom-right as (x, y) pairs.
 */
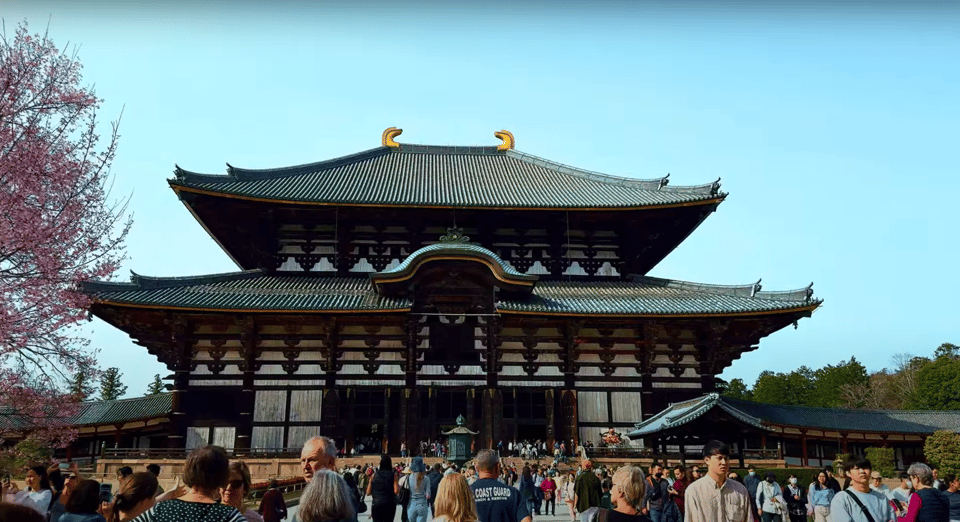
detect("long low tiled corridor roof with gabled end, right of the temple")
(630, 393), (960, 437)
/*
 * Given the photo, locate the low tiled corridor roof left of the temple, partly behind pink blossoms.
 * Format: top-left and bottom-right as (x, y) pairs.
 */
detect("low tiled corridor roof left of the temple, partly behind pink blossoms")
(0, 393), (173, 429)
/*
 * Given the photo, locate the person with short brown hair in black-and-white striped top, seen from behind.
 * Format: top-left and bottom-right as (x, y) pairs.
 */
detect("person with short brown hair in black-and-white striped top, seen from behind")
(130, 446), (244, 522)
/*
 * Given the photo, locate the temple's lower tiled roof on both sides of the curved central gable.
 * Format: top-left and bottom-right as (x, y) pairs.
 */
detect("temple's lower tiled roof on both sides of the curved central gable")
(83, 270), (820, 316)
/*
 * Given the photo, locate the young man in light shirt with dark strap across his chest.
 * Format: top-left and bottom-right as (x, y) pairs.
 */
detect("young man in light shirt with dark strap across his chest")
(829, 457), (896, 522)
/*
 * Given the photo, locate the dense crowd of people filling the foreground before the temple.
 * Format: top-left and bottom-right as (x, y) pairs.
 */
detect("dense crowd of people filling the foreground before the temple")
(0, 437), (960, 522)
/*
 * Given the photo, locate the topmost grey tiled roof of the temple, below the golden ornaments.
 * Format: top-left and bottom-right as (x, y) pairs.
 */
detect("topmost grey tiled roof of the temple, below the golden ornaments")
(170, 144), (725, 209)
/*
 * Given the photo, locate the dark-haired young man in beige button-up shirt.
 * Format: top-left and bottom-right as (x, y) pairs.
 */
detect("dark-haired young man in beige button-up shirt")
(683, 440), (753, 522)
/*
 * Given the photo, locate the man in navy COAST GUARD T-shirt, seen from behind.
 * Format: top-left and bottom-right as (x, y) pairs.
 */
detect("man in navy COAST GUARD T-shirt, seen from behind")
(470, 449), (532, 522)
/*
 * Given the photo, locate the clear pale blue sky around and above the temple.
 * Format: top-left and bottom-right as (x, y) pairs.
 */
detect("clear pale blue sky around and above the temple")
(0, 1), (960, 396)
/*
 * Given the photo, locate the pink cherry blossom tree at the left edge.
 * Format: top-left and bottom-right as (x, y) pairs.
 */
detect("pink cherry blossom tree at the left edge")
(0, 22), (132, 446)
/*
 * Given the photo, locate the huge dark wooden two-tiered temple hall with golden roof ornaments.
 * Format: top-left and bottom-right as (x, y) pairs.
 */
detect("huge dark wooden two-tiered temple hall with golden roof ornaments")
(84, 128), (820, 452)
